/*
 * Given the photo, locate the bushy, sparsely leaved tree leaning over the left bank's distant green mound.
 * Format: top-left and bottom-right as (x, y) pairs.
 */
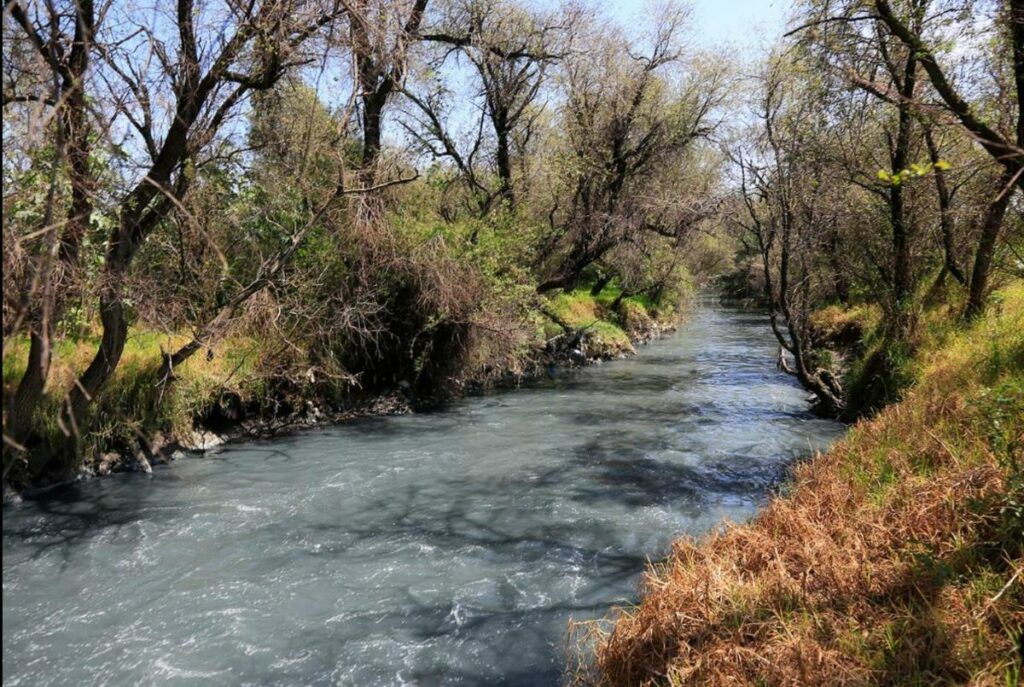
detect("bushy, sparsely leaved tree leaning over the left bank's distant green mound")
(538, 6), (727, 292)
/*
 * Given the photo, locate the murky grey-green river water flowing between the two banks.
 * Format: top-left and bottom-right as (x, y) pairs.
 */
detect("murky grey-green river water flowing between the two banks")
(3, 303), (840, 686)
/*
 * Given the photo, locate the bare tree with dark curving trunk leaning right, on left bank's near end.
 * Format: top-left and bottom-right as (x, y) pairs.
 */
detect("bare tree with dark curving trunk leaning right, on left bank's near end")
(5, 0), (342, 470)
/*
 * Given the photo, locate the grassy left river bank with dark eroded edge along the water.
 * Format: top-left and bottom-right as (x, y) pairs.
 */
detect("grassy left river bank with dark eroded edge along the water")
(4, 287), (692, 503)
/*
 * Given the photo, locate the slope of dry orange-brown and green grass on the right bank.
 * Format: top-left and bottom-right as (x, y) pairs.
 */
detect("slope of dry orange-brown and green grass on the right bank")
(582, 283), (1024, 686)
